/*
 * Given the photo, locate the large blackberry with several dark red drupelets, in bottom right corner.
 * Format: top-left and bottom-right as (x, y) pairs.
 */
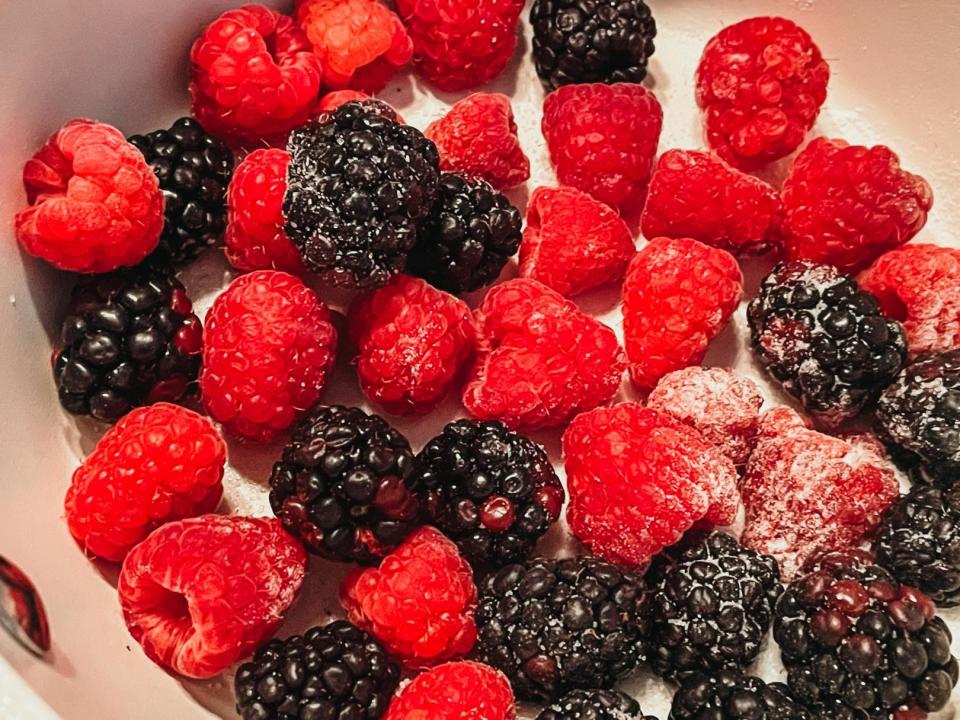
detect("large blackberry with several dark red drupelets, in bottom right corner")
(773, 550), (957, 720)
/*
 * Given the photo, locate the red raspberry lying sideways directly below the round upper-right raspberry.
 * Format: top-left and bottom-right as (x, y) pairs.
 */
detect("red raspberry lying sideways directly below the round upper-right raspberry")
(641, 150), (780, 255)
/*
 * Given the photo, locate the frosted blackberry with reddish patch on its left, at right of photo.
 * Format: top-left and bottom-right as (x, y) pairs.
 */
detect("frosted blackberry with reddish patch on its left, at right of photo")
(748, 261), (907, 427)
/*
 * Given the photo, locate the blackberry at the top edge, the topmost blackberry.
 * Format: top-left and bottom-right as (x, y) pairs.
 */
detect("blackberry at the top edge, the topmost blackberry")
(530, 0), (657, 90)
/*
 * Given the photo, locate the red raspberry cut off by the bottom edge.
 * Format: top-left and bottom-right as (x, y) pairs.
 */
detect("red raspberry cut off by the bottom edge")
(383, 661), (517, 720)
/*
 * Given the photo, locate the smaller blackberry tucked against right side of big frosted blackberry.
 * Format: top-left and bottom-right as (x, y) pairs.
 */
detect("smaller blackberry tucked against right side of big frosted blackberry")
(407, 173), (522, 294)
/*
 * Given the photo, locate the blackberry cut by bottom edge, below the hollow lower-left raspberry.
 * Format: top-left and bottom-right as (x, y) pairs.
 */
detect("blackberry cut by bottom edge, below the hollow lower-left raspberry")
(234, 620), (400, 720)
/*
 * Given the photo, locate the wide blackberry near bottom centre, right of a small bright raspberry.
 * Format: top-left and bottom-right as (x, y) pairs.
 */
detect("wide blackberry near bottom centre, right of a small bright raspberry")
(474, 557), (649, 702)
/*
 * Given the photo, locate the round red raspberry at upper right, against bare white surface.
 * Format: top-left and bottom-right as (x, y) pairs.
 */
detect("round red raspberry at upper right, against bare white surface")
(697, 17), (830, 169)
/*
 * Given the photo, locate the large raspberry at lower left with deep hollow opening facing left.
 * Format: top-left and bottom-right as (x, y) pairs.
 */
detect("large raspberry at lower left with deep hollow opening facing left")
(117, 515), (306, 678)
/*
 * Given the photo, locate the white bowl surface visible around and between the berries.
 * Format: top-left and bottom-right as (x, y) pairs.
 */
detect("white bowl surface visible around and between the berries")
(0, 0), (960, 720)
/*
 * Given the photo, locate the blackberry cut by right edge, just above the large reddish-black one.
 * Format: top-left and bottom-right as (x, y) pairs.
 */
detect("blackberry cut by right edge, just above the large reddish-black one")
(873, 485), (960, 607)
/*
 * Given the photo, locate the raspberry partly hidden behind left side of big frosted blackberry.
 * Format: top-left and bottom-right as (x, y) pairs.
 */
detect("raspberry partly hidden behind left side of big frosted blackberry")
(224, 148), (306, 275)
